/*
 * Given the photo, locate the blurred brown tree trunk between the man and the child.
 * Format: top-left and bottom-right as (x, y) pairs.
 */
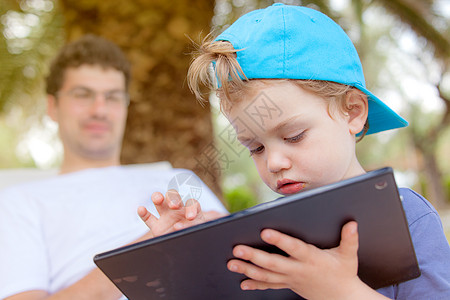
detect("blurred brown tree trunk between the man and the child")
(62, 0), (221, 198)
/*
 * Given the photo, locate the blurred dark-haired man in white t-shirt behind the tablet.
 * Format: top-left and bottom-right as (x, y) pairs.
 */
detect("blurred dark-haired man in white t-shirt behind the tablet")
(0, 35), (225, 300)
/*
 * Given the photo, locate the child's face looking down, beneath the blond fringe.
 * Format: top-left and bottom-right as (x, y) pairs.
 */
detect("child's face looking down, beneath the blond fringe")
(227, 81), (364, 195)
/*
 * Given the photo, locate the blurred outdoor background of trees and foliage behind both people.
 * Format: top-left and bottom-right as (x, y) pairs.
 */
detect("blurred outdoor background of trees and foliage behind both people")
(0, 0), (450, 234)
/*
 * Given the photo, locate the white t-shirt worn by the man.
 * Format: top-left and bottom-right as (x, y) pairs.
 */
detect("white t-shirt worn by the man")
(0, 167), (226, 299)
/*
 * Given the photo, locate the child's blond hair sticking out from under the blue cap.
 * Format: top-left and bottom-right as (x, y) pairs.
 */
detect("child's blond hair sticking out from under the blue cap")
(188, 39), (369, 141)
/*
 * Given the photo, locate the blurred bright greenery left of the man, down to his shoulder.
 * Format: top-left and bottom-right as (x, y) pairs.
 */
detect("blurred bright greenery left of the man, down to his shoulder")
(0, 0), (64, 168)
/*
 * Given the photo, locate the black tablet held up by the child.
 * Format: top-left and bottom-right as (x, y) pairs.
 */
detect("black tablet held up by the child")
(94, 168), (420, 300)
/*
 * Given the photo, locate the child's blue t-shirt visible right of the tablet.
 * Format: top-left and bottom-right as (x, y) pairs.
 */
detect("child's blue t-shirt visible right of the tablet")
(377, 188), (450, 300)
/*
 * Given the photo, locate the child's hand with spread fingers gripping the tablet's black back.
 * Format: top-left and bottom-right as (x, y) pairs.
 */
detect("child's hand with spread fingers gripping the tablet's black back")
(227, 222), (381, 299)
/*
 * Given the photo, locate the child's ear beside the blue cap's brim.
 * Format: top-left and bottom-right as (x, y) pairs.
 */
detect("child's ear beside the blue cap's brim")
(345, 89), (369, 135)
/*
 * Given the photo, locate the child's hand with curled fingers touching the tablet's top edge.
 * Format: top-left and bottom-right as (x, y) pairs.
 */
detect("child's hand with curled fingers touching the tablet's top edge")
(138, 190), (211, 237)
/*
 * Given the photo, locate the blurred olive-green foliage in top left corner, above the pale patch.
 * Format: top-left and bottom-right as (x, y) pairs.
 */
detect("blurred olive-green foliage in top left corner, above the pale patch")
(0, 0), (63, 114)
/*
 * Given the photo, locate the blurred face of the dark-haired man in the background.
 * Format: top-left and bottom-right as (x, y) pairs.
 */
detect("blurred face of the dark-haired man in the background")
(48, 65), (128, 160)
